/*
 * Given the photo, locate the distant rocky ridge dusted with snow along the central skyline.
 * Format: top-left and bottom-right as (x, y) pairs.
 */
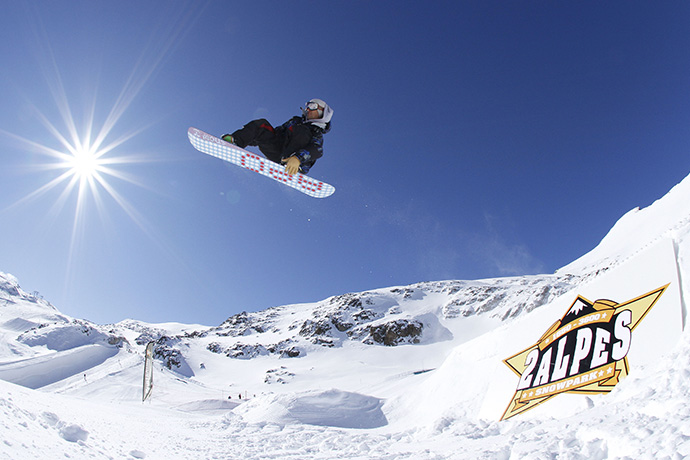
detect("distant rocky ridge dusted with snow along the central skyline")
(98, 274), (586, 376)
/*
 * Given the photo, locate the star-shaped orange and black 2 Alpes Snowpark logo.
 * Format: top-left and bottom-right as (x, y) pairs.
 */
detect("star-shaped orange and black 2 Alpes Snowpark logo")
(501, 284), (669, 420)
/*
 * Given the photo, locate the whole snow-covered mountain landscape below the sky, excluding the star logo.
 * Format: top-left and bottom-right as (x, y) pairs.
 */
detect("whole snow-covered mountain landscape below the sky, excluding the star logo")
(0, 172), (690, 459)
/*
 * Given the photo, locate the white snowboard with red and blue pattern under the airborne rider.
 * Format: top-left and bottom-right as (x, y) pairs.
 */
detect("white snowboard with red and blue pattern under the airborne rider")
(187, 128), (335, 198)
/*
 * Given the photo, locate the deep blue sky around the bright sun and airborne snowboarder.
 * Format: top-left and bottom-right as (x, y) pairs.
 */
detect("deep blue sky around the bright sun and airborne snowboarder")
(0, 0), (690, 325)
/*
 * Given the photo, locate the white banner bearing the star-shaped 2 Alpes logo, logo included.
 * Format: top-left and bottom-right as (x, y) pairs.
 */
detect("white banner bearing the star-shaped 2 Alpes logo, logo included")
(490, 238), (684, 420)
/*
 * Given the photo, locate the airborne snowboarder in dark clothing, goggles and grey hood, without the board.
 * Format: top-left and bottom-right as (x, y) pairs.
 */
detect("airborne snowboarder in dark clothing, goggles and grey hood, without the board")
(222, 99), (333, 176)
